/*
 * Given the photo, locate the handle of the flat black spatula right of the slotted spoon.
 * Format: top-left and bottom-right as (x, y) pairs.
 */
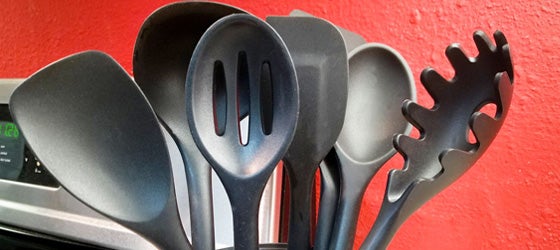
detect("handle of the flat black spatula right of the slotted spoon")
(284, 160), (315, 249)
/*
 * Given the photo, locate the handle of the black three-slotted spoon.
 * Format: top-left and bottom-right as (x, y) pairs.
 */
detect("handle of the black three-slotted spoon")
(226, 183), (264, 250)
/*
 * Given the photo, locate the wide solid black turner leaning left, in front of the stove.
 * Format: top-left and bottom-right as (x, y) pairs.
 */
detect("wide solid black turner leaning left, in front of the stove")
(10, 51), (191, 249)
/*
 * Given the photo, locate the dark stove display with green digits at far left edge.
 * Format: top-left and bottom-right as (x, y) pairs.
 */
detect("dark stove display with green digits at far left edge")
(0, 121), (25, 180)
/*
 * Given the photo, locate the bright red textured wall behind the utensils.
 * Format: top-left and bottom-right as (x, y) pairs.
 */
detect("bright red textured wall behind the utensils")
(0, 0), (560, 249)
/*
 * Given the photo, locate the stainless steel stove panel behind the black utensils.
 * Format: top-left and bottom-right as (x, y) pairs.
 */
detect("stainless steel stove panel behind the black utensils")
(0, 79), (282, 249)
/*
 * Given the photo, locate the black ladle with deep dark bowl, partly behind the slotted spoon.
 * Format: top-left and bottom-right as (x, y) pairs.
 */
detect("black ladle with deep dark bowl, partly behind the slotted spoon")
(133, 2), (247, 249)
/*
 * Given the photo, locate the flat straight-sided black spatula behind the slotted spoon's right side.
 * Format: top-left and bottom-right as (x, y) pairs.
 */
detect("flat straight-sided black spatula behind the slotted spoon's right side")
(266, 17), (348, 249)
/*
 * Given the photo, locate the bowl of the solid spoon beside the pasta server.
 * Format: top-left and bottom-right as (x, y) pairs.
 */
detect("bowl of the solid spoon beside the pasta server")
(336, 43), (416, 164)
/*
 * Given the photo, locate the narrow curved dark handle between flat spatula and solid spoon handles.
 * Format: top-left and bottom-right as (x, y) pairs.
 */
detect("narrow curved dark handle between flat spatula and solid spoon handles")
(314, 149), (340, 249)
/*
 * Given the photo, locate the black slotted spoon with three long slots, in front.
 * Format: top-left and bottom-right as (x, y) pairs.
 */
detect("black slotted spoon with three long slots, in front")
(186, 14), (299, 250)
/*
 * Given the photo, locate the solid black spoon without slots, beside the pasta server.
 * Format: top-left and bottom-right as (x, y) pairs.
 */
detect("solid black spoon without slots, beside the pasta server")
(329, 43), (416, 249)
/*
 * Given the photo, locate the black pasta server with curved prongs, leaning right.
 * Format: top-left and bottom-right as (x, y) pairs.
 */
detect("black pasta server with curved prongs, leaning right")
(361, 31), (513, 249)
